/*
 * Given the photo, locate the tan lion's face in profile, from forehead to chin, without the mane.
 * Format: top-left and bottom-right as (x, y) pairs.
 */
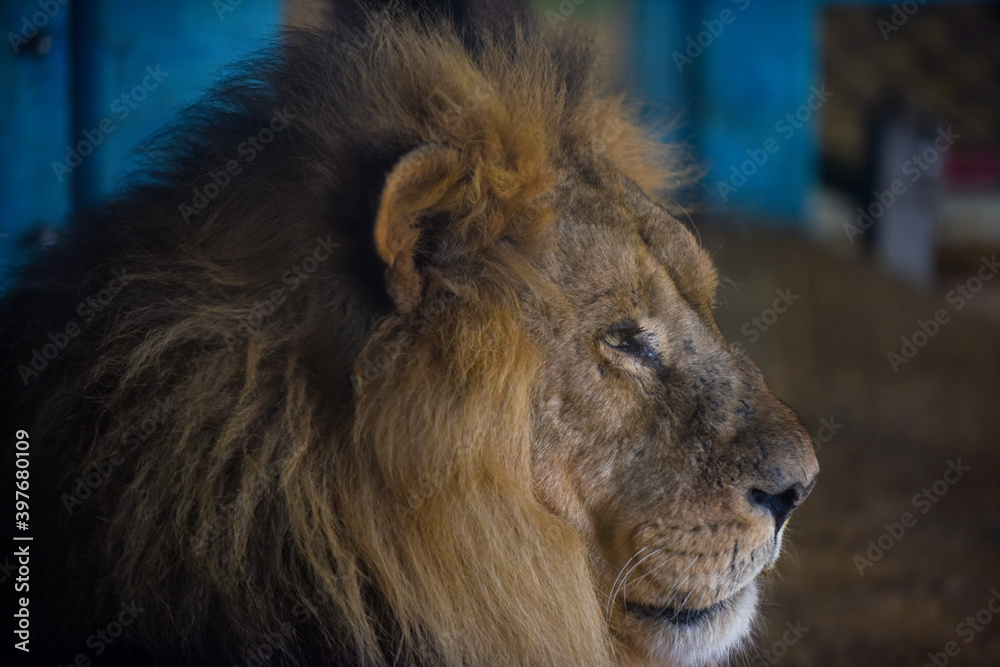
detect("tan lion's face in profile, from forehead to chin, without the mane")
(532, 169), (819, 664)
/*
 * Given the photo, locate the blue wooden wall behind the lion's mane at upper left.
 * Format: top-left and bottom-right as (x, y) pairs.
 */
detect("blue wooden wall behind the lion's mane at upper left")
(0, 0), (281, 282)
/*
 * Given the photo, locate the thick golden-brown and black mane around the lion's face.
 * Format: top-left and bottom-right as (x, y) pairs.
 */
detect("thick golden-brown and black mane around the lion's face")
(2, 10), (675, 665)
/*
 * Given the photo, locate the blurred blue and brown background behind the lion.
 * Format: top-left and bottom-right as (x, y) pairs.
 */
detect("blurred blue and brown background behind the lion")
(0, 0), (1000, 667)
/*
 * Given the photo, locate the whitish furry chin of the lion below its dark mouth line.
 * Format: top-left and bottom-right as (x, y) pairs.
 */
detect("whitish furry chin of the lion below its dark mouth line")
(625, 581), (757, 667)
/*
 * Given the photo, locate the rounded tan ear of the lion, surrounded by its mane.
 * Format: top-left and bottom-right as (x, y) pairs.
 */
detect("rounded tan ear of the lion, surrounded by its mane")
(375, 145), (462, 313)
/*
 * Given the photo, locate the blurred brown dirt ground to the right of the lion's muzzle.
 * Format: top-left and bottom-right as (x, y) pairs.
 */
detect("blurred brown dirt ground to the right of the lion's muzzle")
(701, 227), (1000, 667)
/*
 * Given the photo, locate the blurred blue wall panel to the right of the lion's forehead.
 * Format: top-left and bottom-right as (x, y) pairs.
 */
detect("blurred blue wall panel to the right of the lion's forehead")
(635, 0), (822, 225)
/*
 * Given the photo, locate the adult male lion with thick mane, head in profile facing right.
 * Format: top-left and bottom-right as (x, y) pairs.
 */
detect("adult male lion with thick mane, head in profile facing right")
(2, 8), (818, 666)
